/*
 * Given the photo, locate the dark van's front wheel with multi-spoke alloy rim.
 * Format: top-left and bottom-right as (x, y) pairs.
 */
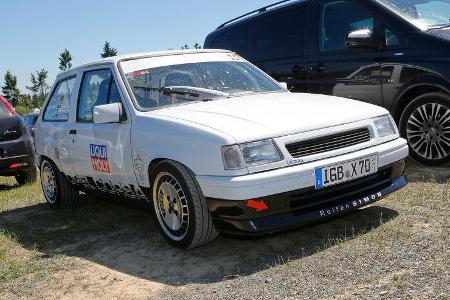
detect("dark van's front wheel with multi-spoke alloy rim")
(399, 93), (450, 166)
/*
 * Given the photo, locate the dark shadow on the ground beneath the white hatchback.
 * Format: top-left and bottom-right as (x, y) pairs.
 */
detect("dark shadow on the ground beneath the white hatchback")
(0, 197), (398, 286)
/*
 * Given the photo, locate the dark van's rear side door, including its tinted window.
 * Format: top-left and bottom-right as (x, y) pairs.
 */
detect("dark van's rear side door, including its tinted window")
(249, 1), (310, 92)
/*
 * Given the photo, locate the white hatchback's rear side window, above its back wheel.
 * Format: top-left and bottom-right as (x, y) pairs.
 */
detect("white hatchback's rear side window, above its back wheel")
(43, 77), (75, 121)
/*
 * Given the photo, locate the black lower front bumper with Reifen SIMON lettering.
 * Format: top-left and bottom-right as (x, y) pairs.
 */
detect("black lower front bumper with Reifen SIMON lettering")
(206, 161), (407, 235)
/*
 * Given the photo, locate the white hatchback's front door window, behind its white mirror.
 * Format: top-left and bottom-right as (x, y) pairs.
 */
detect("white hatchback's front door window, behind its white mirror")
(78, 69), (112, 122)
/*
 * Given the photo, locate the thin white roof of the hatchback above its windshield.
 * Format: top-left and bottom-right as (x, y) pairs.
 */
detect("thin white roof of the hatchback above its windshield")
(57, 49), (231, 78)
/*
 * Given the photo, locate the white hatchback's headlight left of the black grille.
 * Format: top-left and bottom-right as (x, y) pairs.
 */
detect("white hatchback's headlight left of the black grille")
(222, 139), (283, 170)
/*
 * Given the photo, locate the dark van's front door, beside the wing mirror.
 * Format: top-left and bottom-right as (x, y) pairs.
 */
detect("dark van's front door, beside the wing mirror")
(308, 0), (383, 105)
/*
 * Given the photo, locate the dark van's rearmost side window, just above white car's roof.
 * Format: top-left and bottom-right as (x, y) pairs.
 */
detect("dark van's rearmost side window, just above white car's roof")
(211, 25), (250, 58)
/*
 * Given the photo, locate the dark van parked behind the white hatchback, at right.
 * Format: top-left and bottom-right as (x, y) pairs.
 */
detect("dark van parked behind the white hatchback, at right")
(204, 0), (450, 165)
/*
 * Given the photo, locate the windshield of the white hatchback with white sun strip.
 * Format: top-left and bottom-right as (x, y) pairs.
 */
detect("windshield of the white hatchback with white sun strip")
(121, 54), (285, 111)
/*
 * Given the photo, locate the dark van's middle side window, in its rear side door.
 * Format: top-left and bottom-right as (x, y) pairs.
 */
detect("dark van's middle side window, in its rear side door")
(250, 5), (307, 60)
